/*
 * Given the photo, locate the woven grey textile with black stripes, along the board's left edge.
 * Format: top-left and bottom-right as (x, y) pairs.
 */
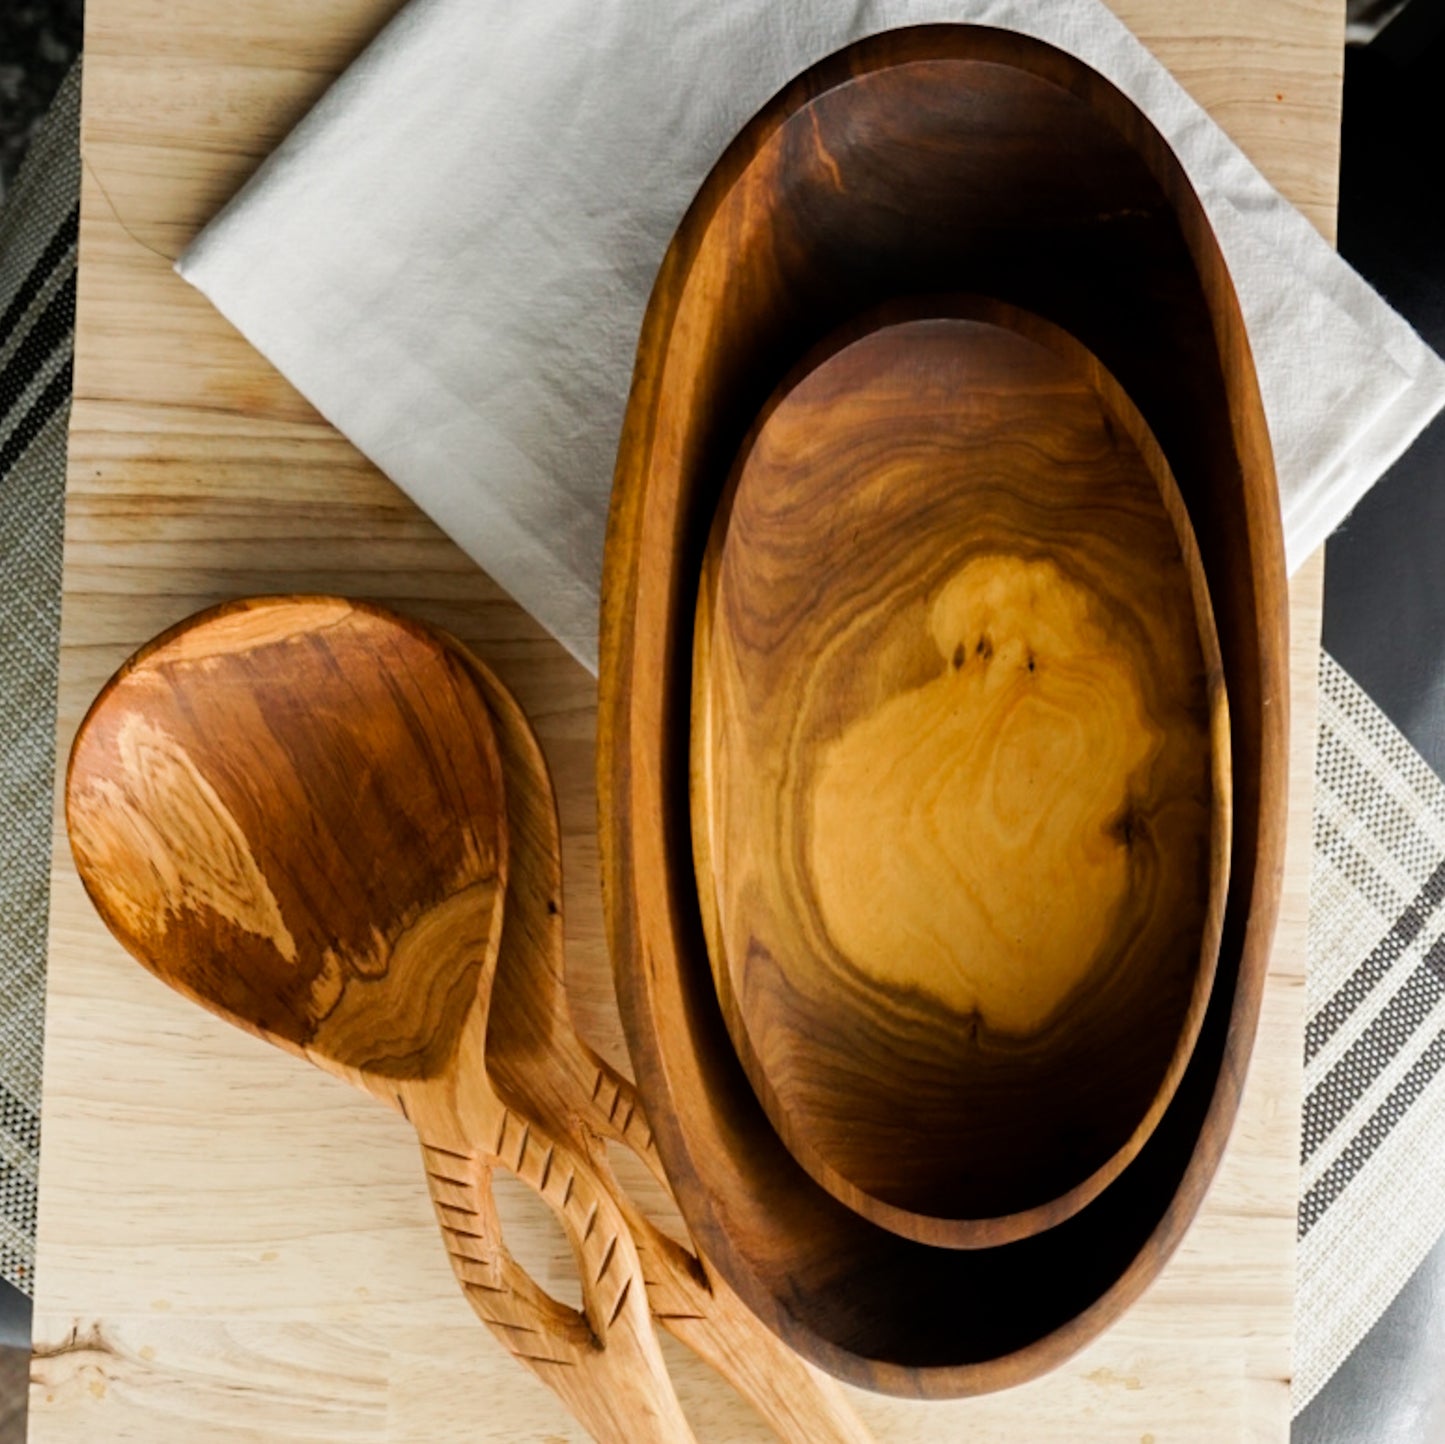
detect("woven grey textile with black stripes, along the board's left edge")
(0, 65), (81, 1294)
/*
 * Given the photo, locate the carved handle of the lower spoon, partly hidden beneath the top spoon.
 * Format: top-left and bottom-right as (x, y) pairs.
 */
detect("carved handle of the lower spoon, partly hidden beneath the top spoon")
(578, 1058), (873, 1444)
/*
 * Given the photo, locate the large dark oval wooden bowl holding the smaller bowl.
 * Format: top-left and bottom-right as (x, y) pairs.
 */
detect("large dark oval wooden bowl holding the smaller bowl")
(598, 26), (1289, 1396)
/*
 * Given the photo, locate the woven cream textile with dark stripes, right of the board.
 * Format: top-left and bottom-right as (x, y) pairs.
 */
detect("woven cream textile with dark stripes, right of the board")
(1295, 653), (1445, 1412)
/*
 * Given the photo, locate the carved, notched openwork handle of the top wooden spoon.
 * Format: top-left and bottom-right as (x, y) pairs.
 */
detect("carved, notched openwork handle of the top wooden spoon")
(422, 1104), (692, 1444)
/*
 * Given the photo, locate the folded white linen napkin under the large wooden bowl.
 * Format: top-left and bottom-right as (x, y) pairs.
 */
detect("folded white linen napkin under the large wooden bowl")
(178, 0), (1445, 671)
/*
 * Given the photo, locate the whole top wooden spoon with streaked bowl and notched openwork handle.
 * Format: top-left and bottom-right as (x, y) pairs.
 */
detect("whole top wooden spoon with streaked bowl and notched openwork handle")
(66, 598), (692, 1444)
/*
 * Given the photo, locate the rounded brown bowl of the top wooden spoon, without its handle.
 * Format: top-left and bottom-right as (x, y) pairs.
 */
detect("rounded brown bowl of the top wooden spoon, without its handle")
(66, 598), (507, 1104)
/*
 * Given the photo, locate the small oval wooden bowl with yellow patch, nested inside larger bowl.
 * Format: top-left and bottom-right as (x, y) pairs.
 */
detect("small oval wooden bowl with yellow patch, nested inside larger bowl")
(691, 298), (1230, 1249)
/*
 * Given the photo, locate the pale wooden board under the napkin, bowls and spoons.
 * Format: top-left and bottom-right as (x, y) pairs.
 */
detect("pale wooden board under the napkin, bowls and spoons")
(30, 0), (1342, 1444)
